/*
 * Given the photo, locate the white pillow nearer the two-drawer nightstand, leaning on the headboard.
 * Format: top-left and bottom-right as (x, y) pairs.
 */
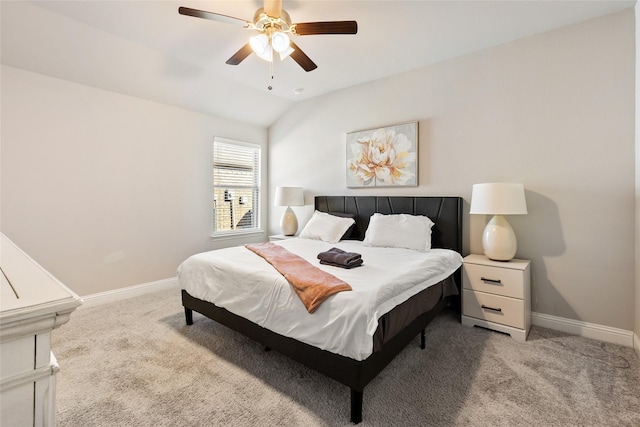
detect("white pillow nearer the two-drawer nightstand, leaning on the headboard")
(363, 213), (433, 252)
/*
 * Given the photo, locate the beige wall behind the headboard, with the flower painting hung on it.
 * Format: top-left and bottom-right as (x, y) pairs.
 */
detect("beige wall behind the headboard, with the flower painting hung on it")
(269, 9), (637, 330)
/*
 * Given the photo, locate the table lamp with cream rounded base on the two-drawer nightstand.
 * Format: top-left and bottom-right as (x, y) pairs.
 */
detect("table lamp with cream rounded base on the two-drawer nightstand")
(469, 182), (527, 261)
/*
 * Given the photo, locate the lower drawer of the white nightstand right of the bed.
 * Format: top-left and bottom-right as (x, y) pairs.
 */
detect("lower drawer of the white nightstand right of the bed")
(462, 289), (525, 329)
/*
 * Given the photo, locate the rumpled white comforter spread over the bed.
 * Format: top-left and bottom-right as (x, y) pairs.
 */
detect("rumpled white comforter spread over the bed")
(178, 238), (462, 360)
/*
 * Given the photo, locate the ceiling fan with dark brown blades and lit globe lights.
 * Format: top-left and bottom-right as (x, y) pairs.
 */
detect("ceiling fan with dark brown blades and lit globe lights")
(178, 0), (358, 72)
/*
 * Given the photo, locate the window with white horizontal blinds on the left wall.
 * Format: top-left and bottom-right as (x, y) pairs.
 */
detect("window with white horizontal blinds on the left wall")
(213, 138), (260, 234)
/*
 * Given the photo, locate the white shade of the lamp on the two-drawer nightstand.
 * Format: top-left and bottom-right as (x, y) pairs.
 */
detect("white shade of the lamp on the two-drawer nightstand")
(469, 182), (527, 215)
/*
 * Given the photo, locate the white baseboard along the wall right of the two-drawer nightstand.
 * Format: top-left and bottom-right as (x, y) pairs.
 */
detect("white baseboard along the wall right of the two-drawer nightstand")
(531, 313), (640, 353)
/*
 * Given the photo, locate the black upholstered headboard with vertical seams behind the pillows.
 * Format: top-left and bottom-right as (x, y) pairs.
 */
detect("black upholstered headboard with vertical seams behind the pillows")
(315, 196), (462, 253)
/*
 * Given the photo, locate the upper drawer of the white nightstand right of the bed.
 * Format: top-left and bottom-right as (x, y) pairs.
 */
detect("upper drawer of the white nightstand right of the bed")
(462, 263), (524, 299)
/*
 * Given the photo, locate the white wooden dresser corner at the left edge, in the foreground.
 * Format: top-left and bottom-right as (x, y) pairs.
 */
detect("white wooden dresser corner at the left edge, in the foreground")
(0, 233), (82, 427)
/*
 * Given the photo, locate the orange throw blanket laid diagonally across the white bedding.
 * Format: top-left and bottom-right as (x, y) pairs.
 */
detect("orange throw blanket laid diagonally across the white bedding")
(245, 242), (351, 313)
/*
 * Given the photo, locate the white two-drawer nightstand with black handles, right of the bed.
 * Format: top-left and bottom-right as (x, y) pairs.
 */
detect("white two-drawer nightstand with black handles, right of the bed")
(462, 255), (531, 341)
